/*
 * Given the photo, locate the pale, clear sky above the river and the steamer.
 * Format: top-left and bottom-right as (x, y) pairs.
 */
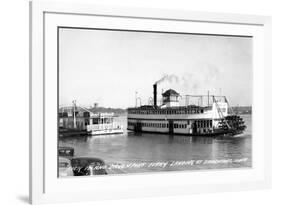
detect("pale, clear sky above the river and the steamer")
(59, 28), (253, 108)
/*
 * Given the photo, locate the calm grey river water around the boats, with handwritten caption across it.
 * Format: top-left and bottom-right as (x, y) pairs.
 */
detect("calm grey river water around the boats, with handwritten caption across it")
(59, 115), (252, 174)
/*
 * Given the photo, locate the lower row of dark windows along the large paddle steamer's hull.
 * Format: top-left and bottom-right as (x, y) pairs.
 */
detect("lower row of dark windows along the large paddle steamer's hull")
(128, 120), (212, 129)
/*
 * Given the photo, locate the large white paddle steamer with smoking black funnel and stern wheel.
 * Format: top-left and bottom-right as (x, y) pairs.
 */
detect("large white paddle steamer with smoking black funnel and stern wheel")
(127, 83), (246, 136)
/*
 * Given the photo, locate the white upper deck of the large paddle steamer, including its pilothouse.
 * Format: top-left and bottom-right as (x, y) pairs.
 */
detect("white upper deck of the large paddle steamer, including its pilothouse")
(127, 89), (228, 119)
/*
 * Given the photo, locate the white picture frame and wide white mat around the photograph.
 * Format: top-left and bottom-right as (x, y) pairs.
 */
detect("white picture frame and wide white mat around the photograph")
(30, 1), (271, 204)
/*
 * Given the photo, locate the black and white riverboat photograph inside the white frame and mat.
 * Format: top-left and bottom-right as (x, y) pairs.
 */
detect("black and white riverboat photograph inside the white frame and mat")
(57, 27), (253, 177)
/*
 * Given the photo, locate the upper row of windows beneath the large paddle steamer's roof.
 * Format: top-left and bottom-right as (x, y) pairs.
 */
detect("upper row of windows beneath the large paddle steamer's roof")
(129, 109), (204, 115)
